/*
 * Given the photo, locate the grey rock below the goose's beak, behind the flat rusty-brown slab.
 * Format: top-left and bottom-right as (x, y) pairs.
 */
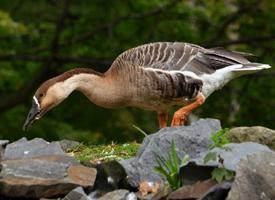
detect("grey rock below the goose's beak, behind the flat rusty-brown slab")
(3, 138), (65, 160)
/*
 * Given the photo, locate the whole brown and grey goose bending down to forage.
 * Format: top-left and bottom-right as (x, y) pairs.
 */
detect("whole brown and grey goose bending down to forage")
(23, 42), (270, 129)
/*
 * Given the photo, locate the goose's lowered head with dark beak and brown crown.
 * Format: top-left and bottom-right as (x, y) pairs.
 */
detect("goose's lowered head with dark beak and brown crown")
(23, 78), (71, 131)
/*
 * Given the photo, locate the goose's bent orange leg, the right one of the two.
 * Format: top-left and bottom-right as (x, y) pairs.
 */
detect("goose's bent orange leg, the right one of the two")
(171, 95), (205, 126)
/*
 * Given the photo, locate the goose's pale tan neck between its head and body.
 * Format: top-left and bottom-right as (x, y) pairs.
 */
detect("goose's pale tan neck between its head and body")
(60, 70), (127, 108)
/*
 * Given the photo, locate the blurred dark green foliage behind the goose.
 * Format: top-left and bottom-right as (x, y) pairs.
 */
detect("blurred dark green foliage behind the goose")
(0, 0), (275, 143)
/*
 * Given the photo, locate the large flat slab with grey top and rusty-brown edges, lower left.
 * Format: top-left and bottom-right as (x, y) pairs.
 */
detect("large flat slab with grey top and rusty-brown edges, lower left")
(0, 155), (96, 198)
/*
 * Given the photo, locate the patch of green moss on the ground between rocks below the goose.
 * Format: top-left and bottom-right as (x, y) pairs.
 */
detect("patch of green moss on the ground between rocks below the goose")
(69, 142), (140, 163)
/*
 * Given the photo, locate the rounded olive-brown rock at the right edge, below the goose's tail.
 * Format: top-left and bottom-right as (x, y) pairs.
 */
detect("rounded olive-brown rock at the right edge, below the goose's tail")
(228, 126), (275, 150)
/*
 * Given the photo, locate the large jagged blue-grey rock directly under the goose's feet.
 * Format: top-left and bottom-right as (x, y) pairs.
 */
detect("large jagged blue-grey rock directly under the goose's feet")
(120, 119), (221, 187)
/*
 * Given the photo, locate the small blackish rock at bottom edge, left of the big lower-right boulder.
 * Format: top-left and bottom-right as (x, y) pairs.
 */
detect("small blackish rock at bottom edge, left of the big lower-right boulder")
(198, 182), (232, 200)
